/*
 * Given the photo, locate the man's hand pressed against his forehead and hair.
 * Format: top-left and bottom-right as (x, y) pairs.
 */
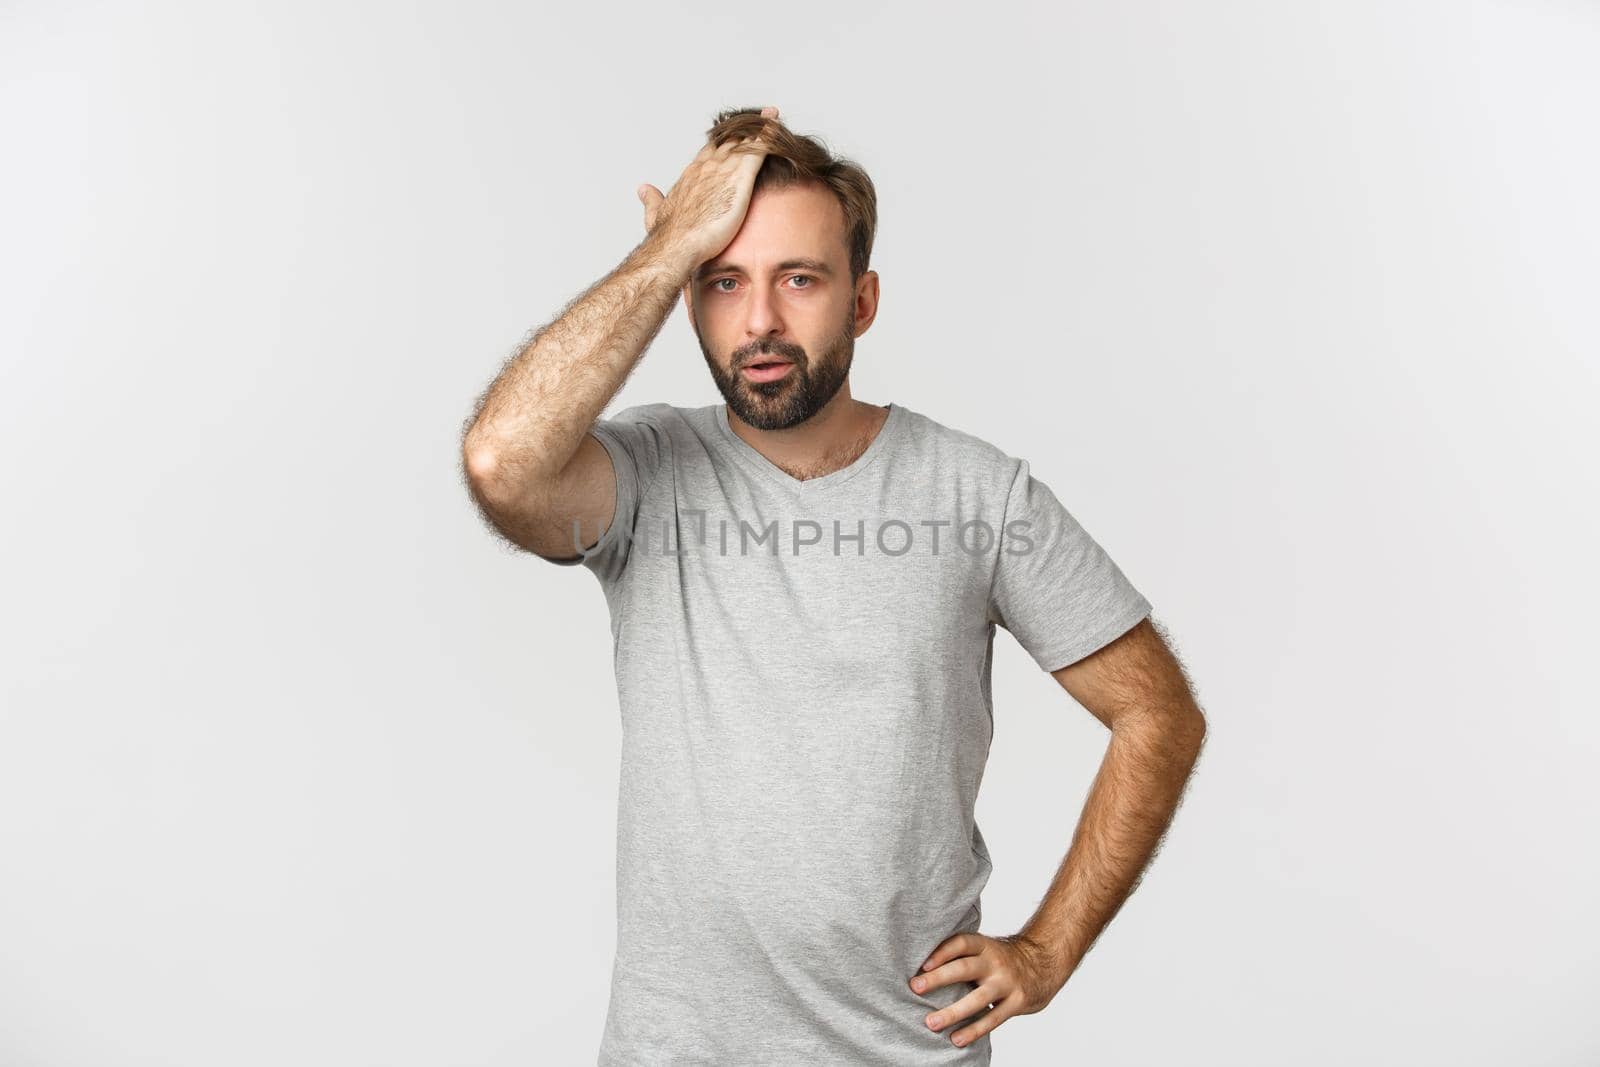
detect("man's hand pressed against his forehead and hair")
(637, 107), (778, 267)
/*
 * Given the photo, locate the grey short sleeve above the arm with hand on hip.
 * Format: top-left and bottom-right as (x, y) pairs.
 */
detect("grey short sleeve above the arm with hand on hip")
(989, 459), (1150, 670)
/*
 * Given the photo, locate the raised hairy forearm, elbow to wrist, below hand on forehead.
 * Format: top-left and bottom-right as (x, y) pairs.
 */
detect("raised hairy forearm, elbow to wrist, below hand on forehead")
(462, 237), (698, 496)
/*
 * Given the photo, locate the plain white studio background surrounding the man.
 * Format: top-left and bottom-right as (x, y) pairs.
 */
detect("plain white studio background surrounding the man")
(0, 0), (1600, 1067)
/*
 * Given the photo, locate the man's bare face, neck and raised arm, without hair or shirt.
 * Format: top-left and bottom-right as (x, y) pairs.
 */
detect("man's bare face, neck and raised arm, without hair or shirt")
(461, 107), (888, 560)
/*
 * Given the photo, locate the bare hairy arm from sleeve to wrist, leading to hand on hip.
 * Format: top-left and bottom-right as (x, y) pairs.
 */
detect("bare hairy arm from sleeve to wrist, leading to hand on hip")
(1018, 619), (1206, 984)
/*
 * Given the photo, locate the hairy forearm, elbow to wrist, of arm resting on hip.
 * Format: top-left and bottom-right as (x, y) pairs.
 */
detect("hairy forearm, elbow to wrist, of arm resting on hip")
(1019, 709), (1205, 984)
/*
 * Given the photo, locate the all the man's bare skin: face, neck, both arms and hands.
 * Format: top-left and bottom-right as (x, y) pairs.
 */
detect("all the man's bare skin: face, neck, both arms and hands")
(462, 107), (1205, 1045)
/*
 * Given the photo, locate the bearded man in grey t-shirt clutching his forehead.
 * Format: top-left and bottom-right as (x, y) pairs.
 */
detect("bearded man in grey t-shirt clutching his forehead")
(462, 107), (1205, 1065)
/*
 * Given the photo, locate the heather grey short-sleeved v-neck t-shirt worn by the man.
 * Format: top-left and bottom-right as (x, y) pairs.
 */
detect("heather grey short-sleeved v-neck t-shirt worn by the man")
(552, 396), (1150, 1067)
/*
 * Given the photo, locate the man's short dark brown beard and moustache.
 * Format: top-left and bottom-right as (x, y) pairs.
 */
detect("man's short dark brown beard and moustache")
(694, 309), (856, 430)
